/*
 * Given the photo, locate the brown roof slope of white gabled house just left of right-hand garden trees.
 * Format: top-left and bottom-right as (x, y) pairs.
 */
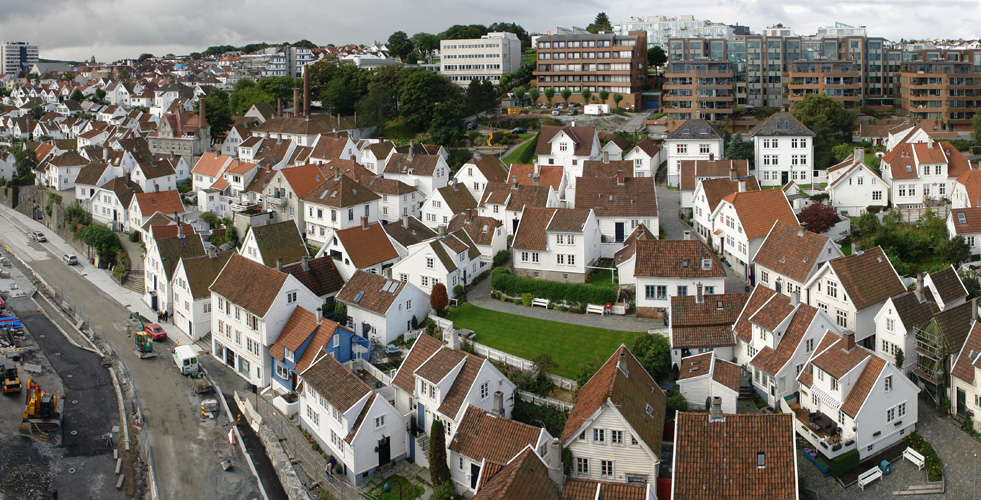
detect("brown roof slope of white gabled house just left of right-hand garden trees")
(829, 247), (906, 310)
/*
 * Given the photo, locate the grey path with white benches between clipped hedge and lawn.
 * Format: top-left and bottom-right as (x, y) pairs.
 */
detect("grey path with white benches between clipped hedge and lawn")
(467, 270), (665, 333)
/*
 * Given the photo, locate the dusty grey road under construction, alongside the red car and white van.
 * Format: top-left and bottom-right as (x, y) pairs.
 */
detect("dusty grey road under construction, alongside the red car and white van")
(0, 209), (259, 499)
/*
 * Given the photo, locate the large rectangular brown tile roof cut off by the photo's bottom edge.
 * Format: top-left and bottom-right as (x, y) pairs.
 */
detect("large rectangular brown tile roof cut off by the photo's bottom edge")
(673, 412), (797, 500)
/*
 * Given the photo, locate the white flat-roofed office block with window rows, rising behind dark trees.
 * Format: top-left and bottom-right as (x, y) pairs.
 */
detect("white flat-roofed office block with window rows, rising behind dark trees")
(439, 32), (521, 87)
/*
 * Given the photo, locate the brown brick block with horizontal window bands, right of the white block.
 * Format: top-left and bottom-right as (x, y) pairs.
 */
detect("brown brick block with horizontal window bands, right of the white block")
(534, 31), (647, 109)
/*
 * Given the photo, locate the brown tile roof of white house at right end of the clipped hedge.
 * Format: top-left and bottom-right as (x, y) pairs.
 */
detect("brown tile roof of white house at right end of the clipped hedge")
(632, 240), (726, 278)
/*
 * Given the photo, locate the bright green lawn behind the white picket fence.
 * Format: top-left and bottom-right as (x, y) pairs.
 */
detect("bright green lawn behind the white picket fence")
(449, 304), (645, 378)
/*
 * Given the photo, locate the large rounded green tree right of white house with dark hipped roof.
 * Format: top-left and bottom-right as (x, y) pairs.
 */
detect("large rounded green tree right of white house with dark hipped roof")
(791, 94), (855, 169)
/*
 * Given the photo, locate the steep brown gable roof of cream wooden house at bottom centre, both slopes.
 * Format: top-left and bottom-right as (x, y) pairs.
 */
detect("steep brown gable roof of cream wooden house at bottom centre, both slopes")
(562, 345), (667, 457)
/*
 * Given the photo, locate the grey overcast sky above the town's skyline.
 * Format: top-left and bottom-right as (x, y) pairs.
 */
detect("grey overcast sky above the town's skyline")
(0, 0), (981, 61)
